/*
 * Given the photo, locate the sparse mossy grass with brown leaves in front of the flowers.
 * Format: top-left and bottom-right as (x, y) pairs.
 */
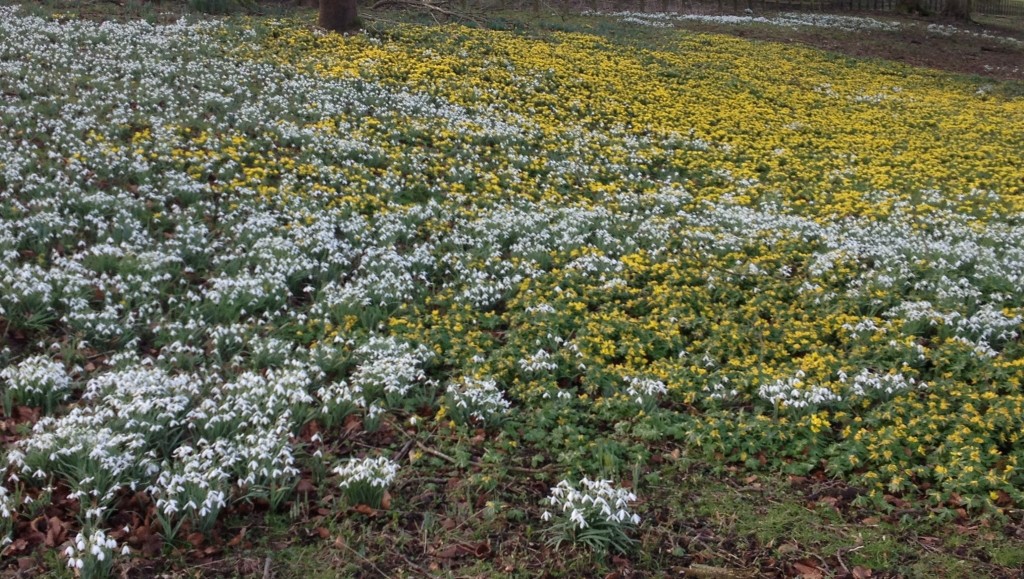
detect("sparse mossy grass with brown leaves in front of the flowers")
(257, 459), (1020, 578)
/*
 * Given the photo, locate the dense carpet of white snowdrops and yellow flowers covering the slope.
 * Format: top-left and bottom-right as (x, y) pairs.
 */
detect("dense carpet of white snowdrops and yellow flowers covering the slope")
(0, 2), (1024, 576)
